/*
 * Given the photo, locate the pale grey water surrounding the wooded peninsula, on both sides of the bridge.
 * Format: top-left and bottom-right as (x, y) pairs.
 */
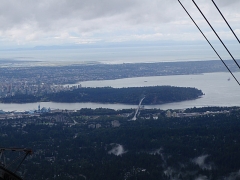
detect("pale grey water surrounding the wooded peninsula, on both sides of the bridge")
(0, 72), (240, 111)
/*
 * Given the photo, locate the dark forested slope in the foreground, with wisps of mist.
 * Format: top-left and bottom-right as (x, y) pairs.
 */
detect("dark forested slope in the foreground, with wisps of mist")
(0, 108), (240, 180)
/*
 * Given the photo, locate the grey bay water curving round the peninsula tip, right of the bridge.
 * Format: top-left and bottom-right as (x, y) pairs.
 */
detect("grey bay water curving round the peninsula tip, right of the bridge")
(80, 72), (240, 109)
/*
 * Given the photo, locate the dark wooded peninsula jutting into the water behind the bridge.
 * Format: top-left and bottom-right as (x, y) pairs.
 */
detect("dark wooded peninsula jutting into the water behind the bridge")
(0, 86), (203, 104)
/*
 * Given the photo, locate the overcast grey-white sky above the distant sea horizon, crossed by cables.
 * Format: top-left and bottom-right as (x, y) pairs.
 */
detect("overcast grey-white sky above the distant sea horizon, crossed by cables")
(0, 0), (240, 62)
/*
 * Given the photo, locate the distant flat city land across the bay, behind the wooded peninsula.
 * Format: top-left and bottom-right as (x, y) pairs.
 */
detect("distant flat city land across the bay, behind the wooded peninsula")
(0, 60), (238, 97)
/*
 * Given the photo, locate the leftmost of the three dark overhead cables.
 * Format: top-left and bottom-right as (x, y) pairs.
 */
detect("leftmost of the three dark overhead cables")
(178, 0), (240, 85)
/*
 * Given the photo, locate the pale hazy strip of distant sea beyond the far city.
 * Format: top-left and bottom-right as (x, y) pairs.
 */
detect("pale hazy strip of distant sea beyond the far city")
(0, 43), (233, 66)
